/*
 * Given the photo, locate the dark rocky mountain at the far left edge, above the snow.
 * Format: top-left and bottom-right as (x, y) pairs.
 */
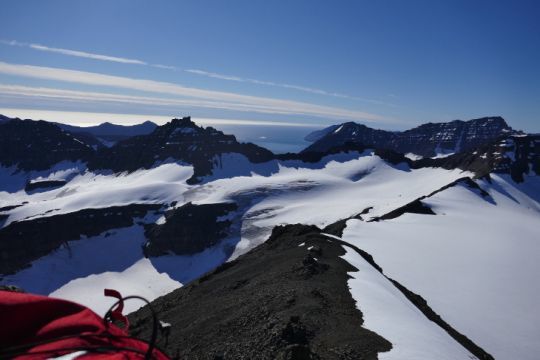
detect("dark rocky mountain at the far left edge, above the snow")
(0, 119), (94, 170)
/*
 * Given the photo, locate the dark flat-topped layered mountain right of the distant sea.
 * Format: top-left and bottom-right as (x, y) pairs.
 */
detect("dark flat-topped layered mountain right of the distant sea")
(303, 117), (513, 157)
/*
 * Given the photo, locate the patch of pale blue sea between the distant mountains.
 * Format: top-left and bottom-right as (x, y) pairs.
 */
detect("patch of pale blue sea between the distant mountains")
(210, 125), (322, 154)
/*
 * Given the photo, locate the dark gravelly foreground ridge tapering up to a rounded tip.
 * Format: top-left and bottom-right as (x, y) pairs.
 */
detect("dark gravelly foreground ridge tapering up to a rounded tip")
(129, 225), (391, 359)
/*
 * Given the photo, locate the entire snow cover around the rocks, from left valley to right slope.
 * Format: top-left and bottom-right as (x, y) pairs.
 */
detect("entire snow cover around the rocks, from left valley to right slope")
(0, 151), (540, 360)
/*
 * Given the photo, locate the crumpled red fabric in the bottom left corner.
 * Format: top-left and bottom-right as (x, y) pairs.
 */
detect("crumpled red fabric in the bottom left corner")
(0, 290), (168, 360)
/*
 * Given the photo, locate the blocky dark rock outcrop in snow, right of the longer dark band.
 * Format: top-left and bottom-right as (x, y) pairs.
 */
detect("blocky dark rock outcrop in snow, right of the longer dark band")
(144, 203), (237, 256)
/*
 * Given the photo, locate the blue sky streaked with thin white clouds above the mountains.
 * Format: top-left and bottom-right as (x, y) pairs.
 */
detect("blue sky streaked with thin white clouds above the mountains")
(0, 0), (540, 132)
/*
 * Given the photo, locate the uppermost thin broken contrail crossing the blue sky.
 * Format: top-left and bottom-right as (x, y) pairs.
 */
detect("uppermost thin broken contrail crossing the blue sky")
(0, 40), (395, 107)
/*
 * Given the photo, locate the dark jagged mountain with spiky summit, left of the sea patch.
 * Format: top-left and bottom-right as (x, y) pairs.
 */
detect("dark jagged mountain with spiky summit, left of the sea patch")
(89, 117), (273, 183)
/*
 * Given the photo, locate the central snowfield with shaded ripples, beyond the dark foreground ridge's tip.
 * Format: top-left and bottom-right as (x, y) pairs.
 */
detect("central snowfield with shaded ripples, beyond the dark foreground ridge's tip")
(193, 151), (472, 258)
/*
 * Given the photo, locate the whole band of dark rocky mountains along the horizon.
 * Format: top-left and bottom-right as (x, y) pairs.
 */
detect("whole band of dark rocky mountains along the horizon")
(0, 117), (535, 182)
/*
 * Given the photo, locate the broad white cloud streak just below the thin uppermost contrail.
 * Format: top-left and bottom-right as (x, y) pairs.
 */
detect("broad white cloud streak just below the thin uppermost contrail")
(0, 62), (395, 122)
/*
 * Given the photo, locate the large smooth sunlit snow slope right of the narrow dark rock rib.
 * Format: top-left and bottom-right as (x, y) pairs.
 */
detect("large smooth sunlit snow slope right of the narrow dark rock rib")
(343, 175), (540, 360)
